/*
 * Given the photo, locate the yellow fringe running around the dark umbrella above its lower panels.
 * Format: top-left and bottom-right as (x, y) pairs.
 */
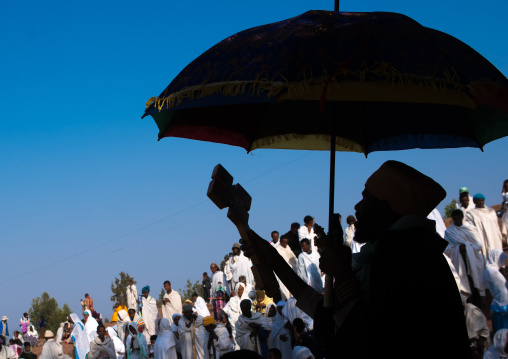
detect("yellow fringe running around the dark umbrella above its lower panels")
(145, 64), (473, 112)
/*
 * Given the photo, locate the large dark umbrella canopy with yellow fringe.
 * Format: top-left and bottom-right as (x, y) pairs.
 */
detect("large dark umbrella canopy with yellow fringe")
(143, 11), (508, 154)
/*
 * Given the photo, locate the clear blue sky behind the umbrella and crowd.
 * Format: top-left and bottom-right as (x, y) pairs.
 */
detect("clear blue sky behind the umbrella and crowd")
(0, 0), (508, 324)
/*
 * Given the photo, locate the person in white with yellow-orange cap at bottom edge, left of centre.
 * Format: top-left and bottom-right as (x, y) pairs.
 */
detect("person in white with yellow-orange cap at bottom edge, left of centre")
(203, 316), (235, 359)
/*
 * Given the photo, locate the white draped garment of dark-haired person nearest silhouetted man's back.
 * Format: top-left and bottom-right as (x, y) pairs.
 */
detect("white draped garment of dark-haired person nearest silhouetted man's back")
(444, 222), (485, 297)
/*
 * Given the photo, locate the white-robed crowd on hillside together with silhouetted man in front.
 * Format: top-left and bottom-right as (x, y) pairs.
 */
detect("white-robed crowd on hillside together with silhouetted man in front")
(0, 161), (508, 359)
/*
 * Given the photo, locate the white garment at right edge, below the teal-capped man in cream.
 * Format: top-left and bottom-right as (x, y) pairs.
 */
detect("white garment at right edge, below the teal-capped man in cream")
(482, 248), (508, 307)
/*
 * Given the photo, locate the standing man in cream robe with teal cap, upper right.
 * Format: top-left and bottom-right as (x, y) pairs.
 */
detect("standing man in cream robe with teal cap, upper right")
(466, 193), (503, 256)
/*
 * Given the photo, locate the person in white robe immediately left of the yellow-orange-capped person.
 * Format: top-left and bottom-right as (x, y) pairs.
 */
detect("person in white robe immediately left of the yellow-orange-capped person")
(178, 304), (205, 359)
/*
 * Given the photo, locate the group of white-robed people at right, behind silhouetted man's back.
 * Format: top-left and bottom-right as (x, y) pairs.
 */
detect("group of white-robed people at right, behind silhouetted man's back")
(436, 186), (508, 352)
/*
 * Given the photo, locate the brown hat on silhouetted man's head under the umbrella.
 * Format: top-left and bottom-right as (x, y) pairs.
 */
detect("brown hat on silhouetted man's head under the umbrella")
(365, 161), (446, 217)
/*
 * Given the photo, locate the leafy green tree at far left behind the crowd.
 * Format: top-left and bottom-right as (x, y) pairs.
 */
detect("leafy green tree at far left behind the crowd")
(28, 292), (72, 333)
